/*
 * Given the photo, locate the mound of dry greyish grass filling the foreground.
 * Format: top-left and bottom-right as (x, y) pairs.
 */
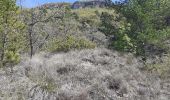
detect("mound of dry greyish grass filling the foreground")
(0, 49), (170, 100)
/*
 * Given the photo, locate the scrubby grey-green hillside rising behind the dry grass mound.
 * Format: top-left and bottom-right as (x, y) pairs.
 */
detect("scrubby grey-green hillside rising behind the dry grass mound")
(19, 4), (124, 53)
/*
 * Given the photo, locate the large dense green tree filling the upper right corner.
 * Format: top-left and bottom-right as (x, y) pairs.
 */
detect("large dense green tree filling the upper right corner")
(112, 0), (170, 55)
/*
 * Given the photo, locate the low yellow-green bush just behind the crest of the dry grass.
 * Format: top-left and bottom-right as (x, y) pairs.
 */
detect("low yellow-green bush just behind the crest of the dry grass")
(43, 36), (96, 52)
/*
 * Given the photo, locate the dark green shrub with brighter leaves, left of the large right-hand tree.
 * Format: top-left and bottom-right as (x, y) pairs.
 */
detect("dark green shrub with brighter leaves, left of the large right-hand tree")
(99, 12), (135, 51)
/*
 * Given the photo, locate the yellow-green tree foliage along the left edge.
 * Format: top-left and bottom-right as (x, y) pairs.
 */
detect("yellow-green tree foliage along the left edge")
(0, 0), (25, 66)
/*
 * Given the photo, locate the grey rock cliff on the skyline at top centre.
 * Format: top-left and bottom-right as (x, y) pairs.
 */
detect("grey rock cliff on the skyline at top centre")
(72, 0), (107, 9)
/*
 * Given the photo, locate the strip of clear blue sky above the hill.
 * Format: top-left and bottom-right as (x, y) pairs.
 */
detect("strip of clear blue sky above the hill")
(17, 0), (118, 8)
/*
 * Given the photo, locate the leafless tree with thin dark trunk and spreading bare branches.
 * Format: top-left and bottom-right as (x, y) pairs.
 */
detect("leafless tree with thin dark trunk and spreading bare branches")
(22, 6), (63, 58)
